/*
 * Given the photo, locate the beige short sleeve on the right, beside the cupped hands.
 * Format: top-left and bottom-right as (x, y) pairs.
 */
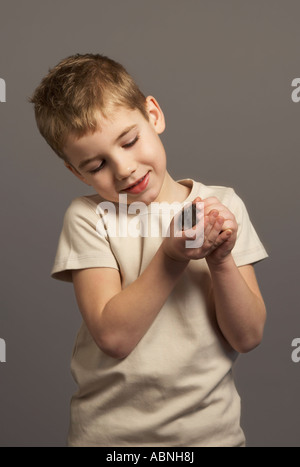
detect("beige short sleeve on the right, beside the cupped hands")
(228, 190), (268, 266)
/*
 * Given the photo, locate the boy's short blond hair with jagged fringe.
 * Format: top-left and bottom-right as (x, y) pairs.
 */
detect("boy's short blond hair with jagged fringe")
(29, 54), (148, 159)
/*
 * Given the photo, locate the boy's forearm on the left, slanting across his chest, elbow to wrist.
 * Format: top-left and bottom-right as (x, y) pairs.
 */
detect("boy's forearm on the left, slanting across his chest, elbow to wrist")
(99, 248), (188, 358)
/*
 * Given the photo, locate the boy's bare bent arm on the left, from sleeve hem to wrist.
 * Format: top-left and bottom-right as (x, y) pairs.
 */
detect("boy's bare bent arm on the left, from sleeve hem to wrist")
(72, 248), (188, 358)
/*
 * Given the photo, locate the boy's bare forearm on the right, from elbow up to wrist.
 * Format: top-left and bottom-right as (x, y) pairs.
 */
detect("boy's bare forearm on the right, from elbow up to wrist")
(207, 255), (266, 353)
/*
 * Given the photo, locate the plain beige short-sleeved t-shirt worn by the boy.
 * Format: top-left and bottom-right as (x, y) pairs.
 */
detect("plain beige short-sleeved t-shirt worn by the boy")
(52, 179), (267, 447)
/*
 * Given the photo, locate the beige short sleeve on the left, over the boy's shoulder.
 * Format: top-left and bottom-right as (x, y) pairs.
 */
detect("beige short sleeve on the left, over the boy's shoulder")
(51, 197), (119, 282)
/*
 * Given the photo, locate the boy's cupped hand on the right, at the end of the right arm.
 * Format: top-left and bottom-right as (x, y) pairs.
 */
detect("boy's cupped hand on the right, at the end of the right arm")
(201, 197), (238, 265)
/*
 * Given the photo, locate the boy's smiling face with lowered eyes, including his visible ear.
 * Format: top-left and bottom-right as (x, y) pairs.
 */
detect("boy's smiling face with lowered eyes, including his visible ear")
(64, 97), (168, 204)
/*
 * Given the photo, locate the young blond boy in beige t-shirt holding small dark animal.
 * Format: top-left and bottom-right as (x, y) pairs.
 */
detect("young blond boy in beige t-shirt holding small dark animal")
(31, 54), (267, 447)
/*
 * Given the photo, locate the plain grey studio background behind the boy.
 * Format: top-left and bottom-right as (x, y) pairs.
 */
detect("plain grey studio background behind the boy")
(0, 0), (300, 446)
